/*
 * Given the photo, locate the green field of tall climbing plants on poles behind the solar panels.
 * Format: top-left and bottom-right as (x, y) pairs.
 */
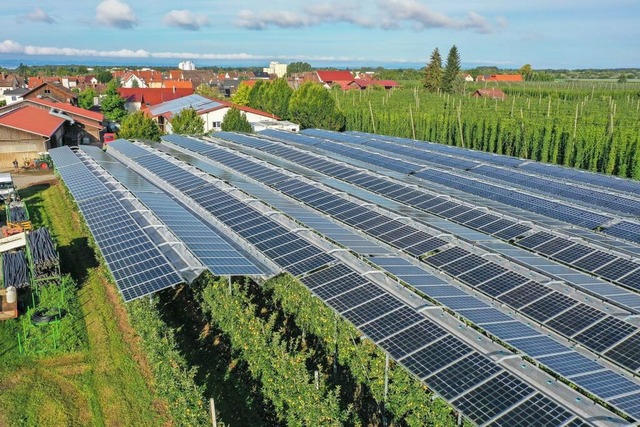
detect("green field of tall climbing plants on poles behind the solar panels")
(333, 82), (640, 179)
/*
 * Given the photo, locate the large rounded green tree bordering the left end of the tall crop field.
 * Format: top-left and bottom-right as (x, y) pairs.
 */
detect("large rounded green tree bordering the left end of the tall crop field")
(289, 82), (346, 131)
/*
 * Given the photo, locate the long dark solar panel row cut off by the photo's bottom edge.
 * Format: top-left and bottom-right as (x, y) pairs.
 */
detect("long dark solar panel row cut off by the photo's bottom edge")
(109, 141), (600, 425)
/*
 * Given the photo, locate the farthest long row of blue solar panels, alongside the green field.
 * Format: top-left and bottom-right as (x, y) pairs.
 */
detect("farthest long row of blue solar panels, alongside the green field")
(303, 129), (640, 216)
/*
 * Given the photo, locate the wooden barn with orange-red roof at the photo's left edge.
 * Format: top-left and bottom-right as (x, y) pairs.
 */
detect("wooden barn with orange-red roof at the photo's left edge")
(0, 105), (66, 168)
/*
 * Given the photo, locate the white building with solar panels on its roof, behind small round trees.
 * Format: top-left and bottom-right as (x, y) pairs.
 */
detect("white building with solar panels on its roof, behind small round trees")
(142, 94), (279, 133)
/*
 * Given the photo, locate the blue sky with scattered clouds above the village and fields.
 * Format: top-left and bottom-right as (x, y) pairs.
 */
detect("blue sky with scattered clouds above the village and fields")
(0, 0), (640, 69)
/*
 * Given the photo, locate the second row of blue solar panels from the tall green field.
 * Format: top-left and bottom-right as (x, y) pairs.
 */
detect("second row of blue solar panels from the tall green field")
(282, 130), (640, 249)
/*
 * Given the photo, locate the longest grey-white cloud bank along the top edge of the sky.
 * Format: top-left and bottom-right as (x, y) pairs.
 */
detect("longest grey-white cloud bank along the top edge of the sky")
(236, 0), (506, 33)
